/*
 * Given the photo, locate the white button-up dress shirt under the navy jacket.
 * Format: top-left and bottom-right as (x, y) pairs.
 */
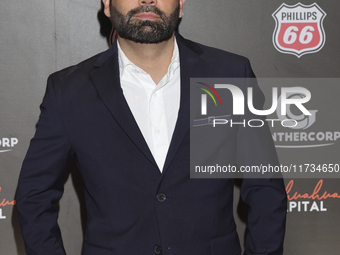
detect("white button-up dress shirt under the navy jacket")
(117, 38), (181, 172)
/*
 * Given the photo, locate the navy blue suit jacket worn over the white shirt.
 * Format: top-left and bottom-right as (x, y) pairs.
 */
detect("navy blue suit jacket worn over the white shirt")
(17, 34), (286, 255)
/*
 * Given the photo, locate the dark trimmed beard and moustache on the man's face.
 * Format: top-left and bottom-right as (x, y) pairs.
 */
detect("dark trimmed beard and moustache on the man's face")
(110, 5), (180, 44)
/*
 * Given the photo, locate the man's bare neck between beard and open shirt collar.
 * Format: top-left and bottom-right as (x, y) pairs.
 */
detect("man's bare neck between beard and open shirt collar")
(118, 35), (174, 84)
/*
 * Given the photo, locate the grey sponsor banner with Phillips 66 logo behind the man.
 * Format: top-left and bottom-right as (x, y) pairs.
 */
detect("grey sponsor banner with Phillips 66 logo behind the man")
(0, 0), (340, 255)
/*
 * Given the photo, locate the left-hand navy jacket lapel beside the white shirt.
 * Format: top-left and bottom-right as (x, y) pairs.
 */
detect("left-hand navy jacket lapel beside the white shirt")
(90, 42), (157, 167)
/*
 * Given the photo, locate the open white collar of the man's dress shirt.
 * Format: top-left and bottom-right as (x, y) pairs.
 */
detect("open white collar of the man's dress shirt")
(117, 37), (180, 77)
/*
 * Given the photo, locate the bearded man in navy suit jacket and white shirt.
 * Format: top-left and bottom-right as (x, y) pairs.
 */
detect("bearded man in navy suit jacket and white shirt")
(17, 0), (286, 255)
